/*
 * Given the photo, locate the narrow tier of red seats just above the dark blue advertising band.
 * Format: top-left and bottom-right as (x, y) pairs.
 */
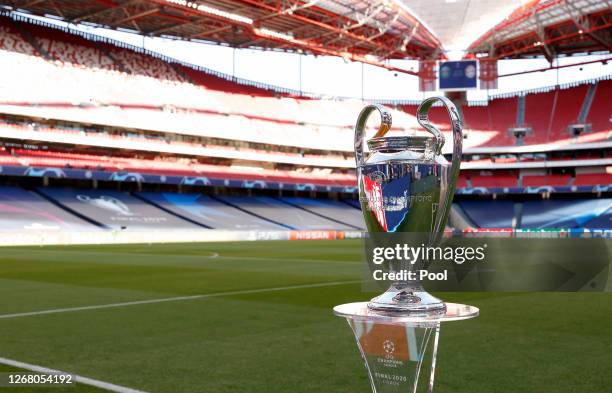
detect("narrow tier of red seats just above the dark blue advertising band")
(0, 140), (612, 189)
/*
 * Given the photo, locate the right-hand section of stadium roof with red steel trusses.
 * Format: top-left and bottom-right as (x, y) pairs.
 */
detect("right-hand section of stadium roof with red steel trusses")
(469, 0), (612, 61)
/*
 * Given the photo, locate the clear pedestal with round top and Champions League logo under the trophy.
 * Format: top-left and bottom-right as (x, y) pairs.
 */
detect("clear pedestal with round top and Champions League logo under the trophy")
(334, 302), (479, 393)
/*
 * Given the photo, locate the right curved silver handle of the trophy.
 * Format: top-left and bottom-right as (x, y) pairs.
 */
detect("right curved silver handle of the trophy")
(417, 97), (463, 244)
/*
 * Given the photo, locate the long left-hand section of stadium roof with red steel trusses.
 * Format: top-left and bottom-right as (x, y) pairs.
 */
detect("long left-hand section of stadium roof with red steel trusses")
(3, 0), (443, 71)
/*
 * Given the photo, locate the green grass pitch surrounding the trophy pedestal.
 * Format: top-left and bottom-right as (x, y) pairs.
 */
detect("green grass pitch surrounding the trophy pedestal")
(0, 240), (612, 393)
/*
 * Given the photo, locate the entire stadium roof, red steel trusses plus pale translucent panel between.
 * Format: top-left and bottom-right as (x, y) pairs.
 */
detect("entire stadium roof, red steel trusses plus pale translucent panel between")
(1, 0), (612, 66)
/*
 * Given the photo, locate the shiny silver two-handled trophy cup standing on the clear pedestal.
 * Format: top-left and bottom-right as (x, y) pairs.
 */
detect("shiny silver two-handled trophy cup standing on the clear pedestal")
(355, 97), (463, 313)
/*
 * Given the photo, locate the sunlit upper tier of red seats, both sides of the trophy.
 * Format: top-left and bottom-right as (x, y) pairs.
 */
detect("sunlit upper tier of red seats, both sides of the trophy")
(0, 17), (612, 151)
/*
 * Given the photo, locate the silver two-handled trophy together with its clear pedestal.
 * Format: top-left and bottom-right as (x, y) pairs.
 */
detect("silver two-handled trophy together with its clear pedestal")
(334, 97), (479, 393)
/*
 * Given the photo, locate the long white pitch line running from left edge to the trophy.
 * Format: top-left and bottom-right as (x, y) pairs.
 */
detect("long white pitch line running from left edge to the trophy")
(0, 280), (361, 319)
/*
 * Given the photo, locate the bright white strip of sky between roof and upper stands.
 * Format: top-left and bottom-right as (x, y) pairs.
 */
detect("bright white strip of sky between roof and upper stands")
(23, 16), (612, 101)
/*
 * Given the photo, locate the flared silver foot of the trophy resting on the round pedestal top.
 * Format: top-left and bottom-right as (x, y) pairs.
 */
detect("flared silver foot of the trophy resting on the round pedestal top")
(368, 285), (446, 314)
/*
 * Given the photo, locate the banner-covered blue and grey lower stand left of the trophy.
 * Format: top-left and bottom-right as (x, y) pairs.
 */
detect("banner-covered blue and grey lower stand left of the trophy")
(0, 187), (363, 231)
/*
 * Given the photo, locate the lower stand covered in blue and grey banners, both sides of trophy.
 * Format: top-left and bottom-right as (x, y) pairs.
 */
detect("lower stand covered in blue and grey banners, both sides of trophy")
(0, 179), (612, 231)
